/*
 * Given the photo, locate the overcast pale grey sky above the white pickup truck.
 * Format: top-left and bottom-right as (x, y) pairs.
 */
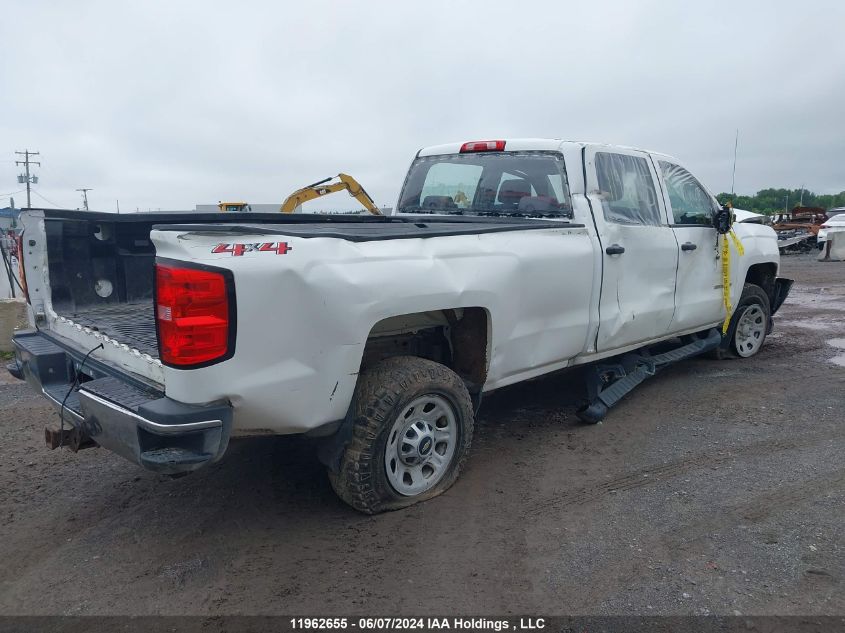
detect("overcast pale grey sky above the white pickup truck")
(0, 0), (845, 211)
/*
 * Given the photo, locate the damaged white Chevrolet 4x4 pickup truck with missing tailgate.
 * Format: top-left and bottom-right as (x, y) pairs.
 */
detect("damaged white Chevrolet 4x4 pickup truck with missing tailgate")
(9, 139), (791, 513)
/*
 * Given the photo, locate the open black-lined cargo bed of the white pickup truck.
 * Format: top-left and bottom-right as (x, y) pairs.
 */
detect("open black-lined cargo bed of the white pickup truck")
(34, 209), (582, 368)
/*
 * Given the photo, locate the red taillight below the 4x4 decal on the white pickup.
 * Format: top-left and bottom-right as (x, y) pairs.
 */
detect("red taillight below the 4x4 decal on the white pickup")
(155, 264), (234, 367)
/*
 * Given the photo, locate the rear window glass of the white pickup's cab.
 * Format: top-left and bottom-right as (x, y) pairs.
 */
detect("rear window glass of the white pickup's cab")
(397, 152), (571, 217)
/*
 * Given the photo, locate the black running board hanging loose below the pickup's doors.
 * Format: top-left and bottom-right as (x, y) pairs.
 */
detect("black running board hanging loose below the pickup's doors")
(576, 328), (722, 424)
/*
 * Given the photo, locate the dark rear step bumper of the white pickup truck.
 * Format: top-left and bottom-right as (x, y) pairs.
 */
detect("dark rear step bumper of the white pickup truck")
(9, 331), (232, 474)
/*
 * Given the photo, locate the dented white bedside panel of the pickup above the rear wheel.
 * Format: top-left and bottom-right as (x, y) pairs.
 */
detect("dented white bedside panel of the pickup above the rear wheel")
(152, 223), (597, 435)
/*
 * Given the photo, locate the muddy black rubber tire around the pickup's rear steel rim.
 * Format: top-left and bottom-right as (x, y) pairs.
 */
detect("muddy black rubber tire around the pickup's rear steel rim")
(329, 356), (473, 514)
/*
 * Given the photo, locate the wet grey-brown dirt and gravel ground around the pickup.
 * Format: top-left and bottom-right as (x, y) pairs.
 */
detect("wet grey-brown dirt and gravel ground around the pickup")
(0, 256), (845, 615)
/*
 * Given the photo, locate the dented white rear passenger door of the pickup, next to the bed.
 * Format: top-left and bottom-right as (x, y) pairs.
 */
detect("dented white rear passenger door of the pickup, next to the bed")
(584, 147), (678, 352)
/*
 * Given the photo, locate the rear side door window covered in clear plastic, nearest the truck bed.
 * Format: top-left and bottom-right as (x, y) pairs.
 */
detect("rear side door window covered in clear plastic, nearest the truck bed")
(596, 152), (662, 226)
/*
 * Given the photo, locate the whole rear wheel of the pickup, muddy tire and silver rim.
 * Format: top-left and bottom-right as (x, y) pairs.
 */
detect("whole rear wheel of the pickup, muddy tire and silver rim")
(329, 356), (473, 514)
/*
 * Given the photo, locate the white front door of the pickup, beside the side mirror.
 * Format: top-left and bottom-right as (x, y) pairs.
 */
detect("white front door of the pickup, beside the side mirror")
(654, 156), (725, 331)
